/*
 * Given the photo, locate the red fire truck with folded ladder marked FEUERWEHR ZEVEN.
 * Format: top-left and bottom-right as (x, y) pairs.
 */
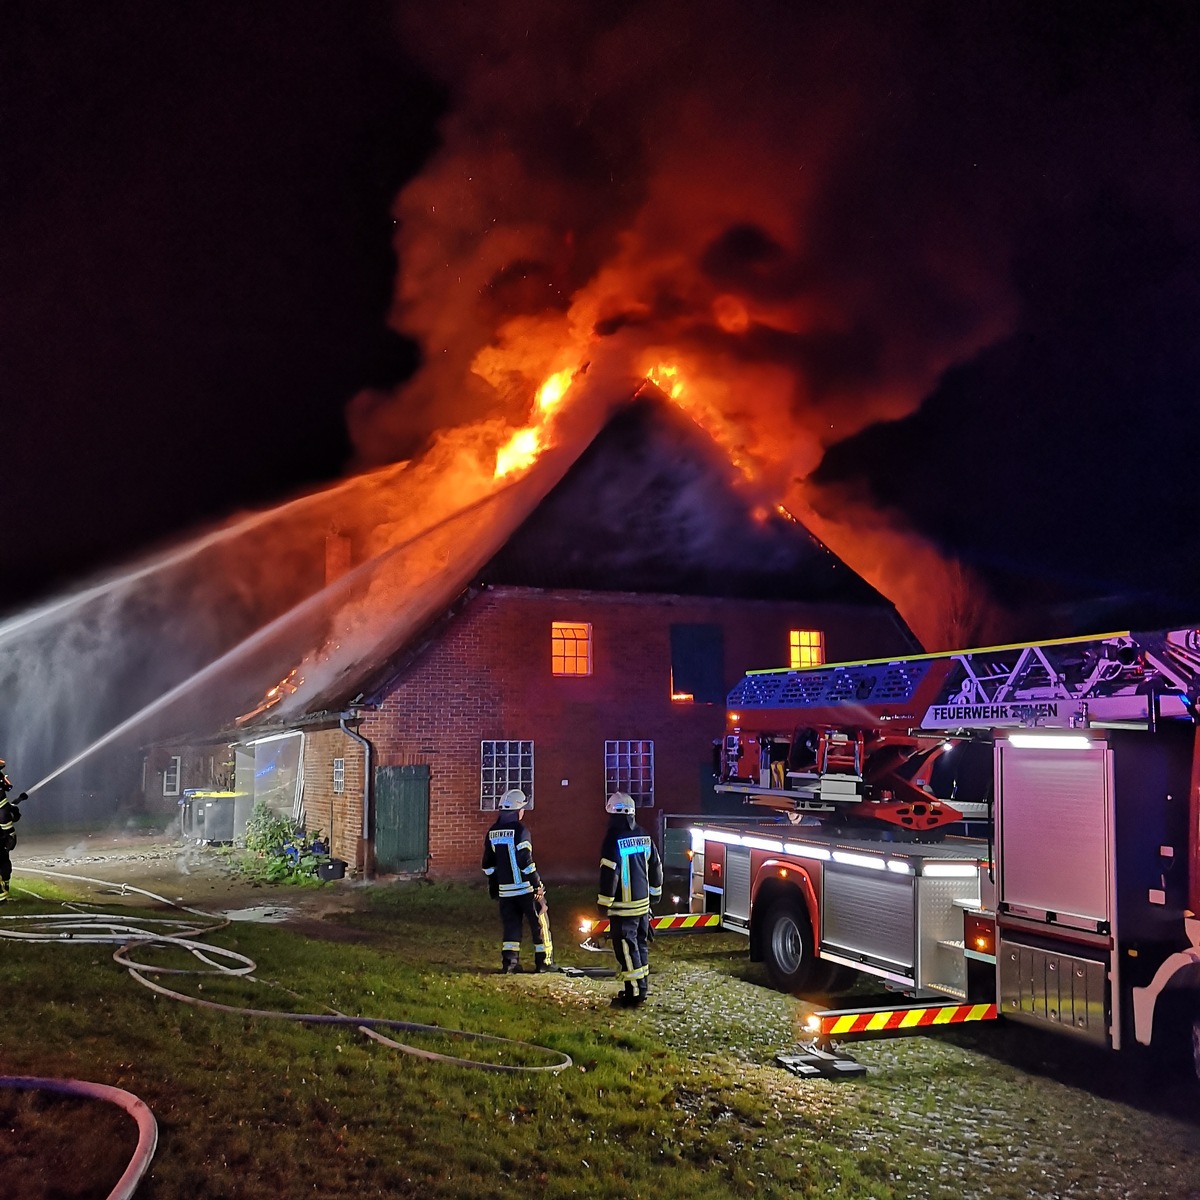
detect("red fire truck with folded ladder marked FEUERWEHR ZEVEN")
(691, 629), (1200, 1073)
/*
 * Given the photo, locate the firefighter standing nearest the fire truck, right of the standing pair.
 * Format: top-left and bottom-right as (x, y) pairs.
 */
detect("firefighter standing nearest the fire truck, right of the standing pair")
(596, 792), (662, 1008)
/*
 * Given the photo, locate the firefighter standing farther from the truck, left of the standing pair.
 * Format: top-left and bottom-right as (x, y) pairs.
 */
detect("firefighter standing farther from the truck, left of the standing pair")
(482, 787), (554, 974)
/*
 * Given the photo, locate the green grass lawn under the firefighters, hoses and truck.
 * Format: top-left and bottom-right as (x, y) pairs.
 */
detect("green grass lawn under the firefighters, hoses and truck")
(0, 883), (1200, 1200)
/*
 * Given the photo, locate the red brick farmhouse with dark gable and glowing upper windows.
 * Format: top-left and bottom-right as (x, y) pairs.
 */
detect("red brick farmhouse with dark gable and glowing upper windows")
(145, 400), (919, 878)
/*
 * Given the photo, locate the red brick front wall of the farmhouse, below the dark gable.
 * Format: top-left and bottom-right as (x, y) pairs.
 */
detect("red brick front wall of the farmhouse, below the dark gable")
(355, 588), (910, 878)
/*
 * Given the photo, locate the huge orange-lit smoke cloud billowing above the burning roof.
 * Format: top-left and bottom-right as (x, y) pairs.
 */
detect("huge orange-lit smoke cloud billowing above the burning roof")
(340, 2), (1051, 638)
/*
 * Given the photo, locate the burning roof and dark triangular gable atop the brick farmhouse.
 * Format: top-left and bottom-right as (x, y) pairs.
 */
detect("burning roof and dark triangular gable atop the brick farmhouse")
(241, 389), (907, 721)
